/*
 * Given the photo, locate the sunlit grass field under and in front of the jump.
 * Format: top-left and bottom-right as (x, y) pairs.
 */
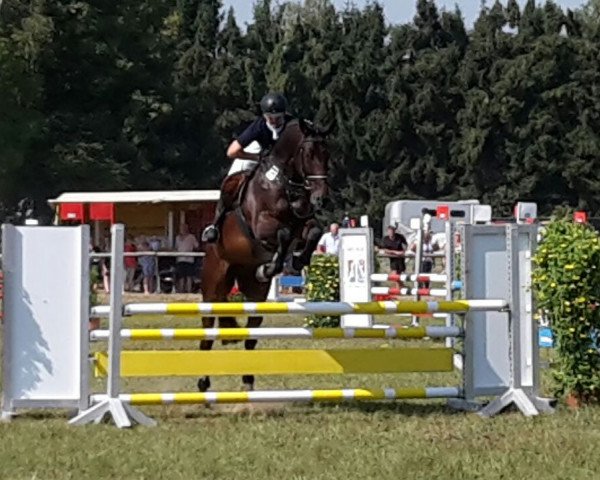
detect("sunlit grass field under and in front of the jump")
(0, 292), (600, 480)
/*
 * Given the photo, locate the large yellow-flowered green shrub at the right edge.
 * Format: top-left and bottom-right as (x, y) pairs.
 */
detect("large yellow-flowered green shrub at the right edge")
(532, 218), (600, 403)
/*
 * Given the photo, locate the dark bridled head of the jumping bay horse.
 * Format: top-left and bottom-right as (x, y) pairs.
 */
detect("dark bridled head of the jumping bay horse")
(292, 120), (332, 208)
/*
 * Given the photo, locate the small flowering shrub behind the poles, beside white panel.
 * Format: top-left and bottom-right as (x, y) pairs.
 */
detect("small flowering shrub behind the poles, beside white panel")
(305, 255), (340, 327)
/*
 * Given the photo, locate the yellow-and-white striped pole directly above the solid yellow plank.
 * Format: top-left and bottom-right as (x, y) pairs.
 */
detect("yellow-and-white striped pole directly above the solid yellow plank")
(90, 326), (463, 341)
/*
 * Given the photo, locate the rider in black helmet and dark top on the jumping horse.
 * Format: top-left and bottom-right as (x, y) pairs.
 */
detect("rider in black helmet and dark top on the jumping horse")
(202, 93), (292, 243)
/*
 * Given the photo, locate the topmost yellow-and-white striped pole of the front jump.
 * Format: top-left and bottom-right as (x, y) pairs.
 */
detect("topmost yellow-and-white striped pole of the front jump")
(92, 300), (508, 316)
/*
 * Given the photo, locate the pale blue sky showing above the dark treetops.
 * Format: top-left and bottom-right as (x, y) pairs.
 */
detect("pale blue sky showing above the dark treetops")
(223, 0), (586, 30)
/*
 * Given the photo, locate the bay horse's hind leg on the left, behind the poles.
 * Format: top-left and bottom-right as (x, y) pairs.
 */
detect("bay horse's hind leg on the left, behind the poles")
(198, 247), (234, 392)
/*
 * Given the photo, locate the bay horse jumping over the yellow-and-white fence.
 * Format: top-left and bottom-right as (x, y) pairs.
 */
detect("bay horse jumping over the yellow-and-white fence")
(198, 119), (331, 392)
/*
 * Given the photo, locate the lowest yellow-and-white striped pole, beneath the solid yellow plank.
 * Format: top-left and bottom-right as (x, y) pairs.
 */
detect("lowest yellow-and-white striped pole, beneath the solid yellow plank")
(92, 387), (461, 406)
